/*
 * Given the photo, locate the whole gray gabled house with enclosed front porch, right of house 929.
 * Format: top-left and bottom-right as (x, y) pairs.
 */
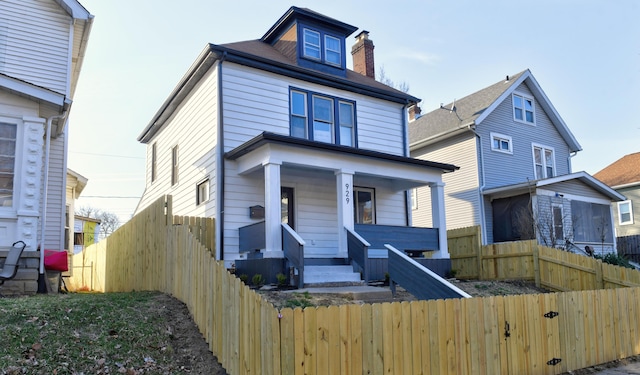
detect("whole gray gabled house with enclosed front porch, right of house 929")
(409, 70), (624, 252)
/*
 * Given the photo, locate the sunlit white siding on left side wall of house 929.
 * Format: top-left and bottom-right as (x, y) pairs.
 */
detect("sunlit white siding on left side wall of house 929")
(137, 66), (218, 217)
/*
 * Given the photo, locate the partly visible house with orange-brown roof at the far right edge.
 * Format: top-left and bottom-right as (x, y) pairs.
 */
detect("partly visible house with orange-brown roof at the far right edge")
(594, 152), (640, 237)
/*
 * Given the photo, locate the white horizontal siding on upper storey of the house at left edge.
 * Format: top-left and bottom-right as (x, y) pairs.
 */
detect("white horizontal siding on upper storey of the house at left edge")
(0, 0), (72, 95)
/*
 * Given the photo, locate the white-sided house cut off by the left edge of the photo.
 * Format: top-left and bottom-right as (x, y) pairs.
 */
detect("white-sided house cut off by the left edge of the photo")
(0, 0), (93, 250)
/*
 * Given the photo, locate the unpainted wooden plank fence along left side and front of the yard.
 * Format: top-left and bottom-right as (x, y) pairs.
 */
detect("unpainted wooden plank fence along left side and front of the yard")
(65, 209), (640, 375)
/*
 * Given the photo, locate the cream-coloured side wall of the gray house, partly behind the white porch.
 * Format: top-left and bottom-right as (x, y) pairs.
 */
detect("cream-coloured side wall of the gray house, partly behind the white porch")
(411, 132), (481, 229)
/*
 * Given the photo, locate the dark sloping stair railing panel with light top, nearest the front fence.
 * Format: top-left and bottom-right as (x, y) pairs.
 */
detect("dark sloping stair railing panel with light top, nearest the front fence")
(385, 244), (471, 300)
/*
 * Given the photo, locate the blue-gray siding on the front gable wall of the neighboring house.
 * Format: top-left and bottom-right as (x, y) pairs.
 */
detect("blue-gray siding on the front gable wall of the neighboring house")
(476, 83), (569, 188)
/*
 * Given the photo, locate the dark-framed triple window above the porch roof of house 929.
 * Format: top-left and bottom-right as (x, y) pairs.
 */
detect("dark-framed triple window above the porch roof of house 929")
(290, 89), (356, 147)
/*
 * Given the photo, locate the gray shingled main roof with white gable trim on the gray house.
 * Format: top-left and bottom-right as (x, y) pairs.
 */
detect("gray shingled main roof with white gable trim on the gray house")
(409, 69), (582, 152)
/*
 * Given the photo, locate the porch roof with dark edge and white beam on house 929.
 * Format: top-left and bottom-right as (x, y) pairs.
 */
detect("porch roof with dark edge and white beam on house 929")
(225, 133), (458, 190)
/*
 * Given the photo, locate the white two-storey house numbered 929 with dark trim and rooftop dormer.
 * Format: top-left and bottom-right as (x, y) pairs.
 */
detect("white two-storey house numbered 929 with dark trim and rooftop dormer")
(138, 7), (456, 284)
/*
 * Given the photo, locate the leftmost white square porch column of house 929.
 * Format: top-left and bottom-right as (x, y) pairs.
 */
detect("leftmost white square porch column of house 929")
(262, 162), (284, 258)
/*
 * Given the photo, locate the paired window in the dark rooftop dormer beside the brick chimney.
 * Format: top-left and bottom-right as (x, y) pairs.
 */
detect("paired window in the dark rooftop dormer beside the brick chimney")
(302, 28), (343, 68)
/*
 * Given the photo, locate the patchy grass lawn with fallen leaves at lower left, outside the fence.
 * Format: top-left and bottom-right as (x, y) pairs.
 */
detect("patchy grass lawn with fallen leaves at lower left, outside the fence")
(0, 292), (225, 375)
